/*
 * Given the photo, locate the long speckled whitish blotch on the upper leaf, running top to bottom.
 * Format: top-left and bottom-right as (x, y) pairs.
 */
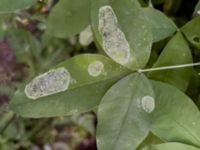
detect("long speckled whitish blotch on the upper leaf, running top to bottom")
(98, 5), (130, 64)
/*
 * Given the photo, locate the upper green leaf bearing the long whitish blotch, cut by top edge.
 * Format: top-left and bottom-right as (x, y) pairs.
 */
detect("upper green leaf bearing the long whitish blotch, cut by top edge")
(91, 0), (153, 70)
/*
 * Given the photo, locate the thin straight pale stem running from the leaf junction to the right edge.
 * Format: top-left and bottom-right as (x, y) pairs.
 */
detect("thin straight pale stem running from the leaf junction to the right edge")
(138, 62), (200, 73)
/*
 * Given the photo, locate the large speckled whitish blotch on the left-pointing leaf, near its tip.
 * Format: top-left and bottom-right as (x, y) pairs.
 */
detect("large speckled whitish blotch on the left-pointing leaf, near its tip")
(25, 67), (71, 99)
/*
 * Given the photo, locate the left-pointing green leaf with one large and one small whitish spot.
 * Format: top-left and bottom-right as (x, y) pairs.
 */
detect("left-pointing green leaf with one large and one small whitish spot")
(10, 54), (129, 118)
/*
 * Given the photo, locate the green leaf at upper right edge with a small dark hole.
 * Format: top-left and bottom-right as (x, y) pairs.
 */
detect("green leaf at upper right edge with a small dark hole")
(181, 17), (200, 49)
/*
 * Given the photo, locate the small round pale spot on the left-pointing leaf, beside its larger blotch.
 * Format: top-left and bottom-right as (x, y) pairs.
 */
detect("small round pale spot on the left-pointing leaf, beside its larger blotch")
(88, 61), (104, 77)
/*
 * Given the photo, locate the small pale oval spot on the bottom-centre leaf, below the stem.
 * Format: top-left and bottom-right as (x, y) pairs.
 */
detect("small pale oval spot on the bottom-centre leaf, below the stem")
(141, 96), (155, 113)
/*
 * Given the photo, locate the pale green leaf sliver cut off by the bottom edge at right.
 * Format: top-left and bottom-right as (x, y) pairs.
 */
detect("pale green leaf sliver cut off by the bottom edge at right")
(143, 142), (200, 150)
